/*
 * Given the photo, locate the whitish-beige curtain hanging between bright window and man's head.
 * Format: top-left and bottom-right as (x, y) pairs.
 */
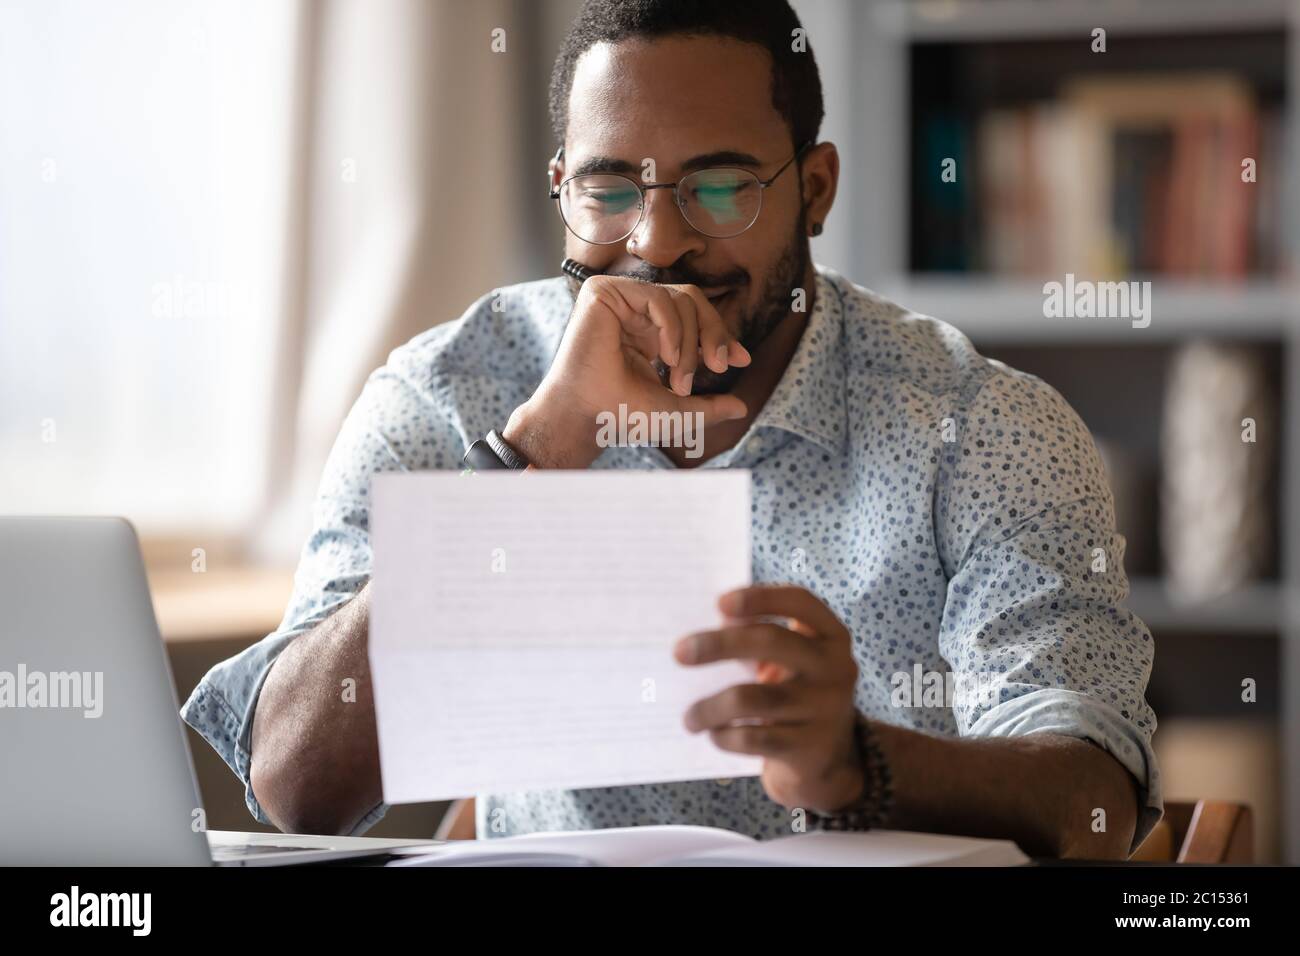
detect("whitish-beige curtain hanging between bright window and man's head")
(250, 0), (559, 561)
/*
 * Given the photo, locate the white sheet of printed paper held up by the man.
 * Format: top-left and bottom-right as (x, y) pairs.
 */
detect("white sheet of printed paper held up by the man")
(369, 470), (762, 804)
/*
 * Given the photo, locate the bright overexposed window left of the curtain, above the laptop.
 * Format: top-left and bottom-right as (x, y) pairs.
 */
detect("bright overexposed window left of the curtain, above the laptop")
(0, 0), (302, 535)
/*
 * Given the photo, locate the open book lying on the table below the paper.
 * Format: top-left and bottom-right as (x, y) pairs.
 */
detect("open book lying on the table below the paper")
(389, 826), (1028, 866)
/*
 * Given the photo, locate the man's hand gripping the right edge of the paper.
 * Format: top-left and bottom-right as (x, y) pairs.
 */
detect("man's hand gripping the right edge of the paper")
(675, 587), (863, 813)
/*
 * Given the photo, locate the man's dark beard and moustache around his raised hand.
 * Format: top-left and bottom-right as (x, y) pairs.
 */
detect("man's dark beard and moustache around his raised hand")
(568, 208), (811, 395)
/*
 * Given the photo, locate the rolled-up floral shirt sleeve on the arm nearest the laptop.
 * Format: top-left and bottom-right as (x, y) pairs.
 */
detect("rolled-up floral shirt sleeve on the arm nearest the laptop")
(181, 348), (462, 834)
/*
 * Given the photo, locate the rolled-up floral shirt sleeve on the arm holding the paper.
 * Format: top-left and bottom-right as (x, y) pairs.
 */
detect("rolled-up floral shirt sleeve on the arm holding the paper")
(935, 367), (1164, 848)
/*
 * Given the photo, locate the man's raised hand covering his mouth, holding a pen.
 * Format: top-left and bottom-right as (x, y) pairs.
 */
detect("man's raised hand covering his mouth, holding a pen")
(502, 276), (750, 468)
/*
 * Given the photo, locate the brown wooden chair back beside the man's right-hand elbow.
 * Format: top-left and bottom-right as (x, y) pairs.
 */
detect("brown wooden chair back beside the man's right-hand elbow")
(1130, 800), (1255, 864)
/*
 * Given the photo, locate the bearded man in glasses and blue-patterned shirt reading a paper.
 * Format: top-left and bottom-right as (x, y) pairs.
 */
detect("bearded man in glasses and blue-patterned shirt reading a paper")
(183, 0), (1162, 858)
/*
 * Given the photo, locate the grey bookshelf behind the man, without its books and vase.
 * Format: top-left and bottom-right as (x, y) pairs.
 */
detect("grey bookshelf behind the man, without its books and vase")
(832, 0), (1300, 864)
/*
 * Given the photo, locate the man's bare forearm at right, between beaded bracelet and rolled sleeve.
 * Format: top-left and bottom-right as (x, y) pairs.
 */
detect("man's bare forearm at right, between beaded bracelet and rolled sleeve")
(871, 721), (1138, 860)
